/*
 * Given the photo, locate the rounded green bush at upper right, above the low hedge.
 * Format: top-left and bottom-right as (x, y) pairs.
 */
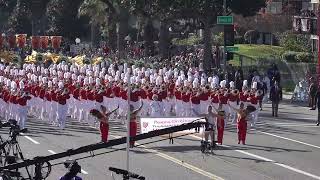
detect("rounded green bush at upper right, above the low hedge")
(278, 32), (311, 52)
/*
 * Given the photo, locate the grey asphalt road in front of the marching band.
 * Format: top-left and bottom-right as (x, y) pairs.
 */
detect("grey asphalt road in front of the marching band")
(0, 98), (320, 180)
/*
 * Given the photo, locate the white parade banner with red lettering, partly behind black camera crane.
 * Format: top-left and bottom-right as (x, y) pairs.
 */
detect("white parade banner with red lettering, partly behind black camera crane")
(140, 117), (205, 134)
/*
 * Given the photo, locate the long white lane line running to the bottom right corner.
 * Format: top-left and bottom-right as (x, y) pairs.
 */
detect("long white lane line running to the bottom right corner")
(190, 135), (320, 180)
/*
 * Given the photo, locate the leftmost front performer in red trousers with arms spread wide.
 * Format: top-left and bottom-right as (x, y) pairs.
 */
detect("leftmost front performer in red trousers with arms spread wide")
(90, 106), (119, 142)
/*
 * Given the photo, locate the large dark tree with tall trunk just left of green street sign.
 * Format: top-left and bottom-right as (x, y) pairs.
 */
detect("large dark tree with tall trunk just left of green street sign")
(171, 0), (265, 71)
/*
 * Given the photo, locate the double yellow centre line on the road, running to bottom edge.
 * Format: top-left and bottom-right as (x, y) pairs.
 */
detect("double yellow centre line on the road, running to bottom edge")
(111, 135), (224, 180)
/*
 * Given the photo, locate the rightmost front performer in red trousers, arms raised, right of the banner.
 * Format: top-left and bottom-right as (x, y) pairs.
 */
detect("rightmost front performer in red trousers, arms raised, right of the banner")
(229, 103), (249, 145)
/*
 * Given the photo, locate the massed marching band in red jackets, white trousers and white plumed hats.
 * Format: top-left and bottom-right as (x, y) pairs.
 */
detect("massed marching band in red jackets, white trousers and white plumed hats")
(0, 62), (264, 143)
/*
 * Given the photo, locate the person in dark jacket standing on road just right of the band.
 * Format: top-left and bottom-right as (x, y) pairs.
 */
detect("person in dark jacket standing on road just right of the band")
(270, 81), (282, 117)
